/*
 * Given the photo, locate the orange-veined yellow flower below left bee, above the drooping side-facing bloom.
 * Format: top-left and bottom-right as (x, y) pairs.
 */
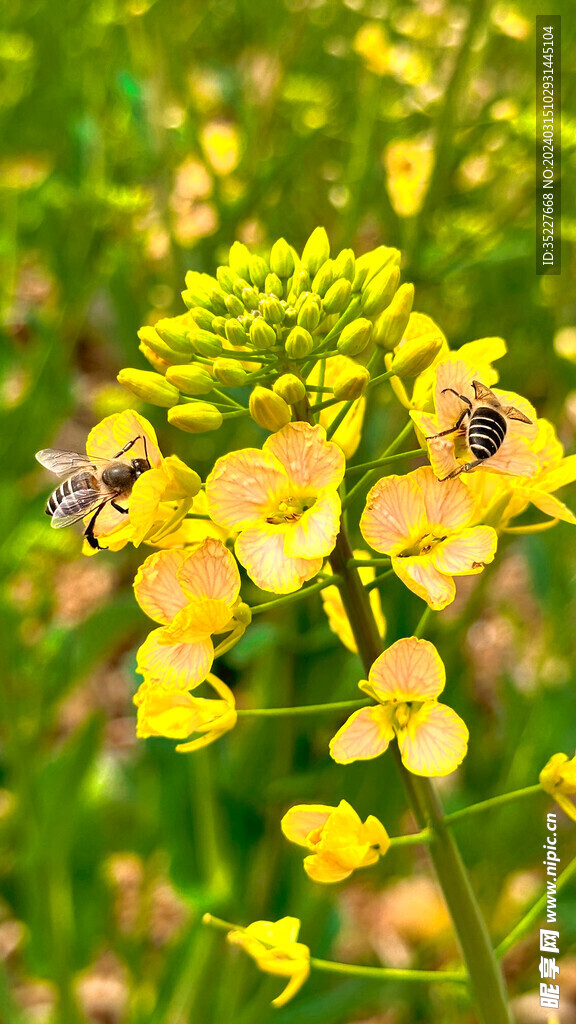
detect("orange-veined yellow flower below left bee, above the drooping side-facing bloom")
(134, 538), (245, 690)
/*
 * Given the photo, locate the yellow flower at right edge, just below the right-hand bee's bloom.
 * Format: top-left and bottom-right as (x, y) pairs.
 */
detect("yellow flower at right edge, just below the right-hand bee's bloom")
(465, 420), (576, 531)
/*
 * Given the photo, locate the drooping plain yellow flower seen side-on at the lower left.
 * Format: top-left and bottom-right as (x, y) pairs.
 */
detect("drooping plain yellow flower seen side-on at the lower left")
(134, 674), (238, 753)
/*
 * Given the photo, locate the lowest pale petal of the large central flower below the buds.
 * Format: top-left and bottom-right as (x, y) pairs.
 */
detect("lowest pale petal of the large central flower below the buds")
(236, 523), (322, 594)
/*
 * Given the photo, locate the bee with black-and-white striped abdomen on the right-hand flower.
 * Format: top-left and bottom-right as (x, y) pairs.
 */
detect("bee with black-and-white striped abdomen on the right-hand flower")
(426, 381), (532, 480)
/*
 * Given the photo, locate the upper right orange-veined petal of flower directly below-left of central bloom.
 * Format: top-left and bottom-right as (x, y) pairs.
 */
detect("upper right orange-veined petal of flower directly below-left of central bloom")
(177, 538), (240, 602)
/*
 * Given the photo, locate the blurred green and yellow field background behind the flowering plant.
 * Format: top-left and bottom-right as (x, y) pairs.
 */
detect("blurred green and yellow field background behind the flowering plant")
(0, 0), (576, 1024)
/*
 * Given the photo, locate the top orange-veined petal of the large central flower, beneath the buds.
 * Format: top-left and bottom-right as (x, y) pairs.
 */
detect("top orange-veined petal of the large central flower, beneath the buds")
(263, 423), (345, 493)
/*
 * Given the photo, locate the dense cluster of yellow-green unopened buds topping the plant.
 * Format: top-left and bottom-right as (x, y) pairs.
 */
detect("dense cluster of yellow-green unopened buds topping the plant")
(118, 227), (422, 432)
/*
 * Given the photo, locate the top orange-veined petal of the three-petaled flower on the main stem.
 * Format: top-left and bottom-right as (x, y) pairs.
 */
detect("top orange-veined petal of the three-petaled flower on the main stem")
(362, 637), (446, 702)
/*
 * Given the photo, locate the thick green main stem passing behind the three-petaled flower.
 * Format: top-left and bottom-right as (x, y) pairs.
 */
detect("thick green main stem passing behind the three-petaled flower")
(330, 528), (510, 1024)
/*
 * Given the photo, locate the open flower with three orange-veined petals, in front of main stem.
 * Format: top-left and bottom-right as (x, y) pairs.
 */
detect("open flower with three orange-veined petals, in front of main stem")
(330, 637), (468, 777)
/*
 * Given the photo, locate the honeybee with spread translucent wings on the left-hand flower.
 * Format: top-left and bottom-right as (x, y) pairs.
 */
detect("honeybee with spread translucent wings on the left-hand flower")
(36, 435), (151, 551)
